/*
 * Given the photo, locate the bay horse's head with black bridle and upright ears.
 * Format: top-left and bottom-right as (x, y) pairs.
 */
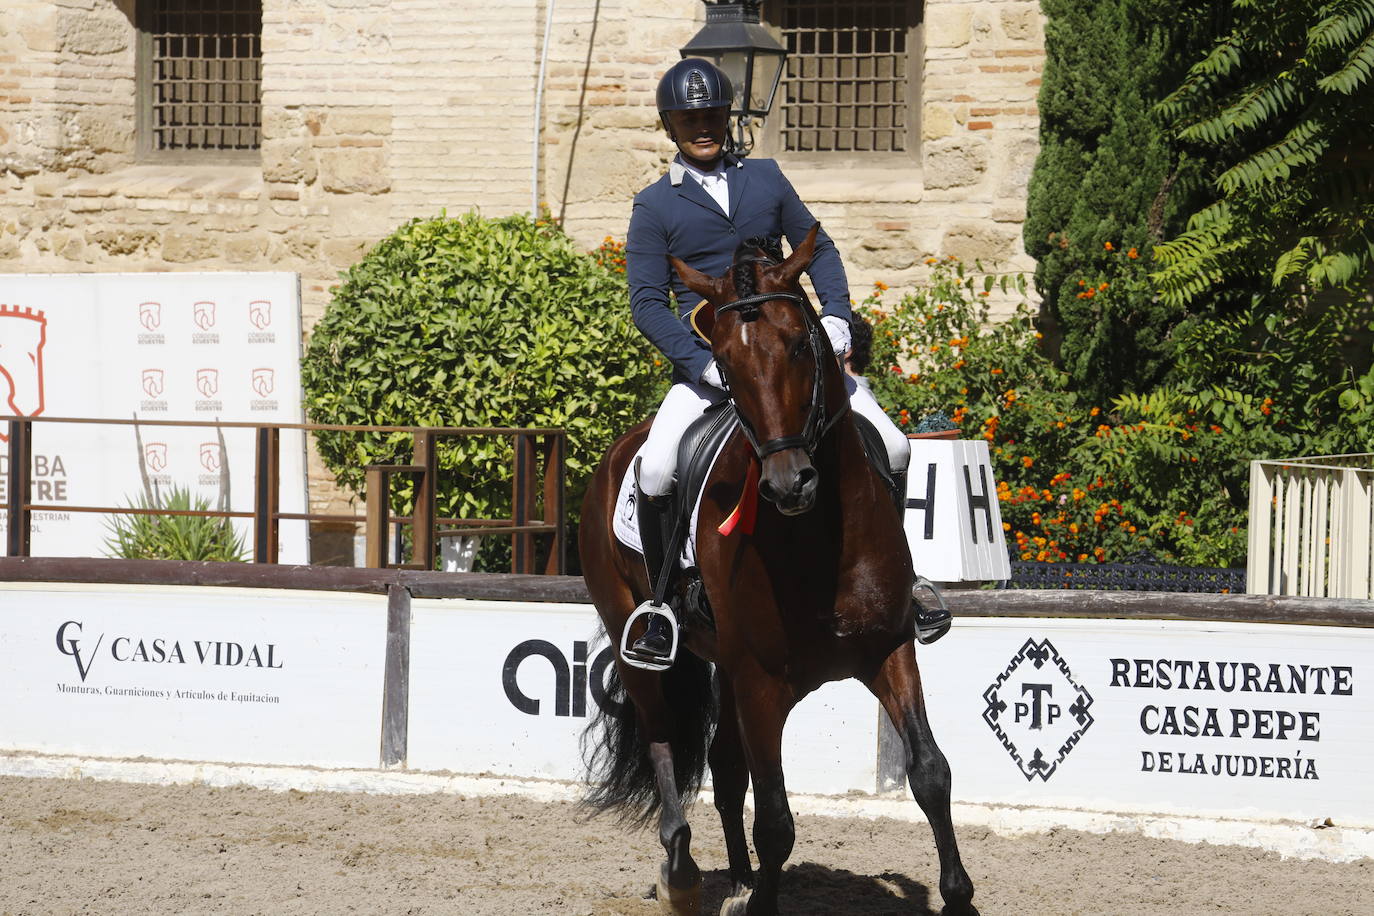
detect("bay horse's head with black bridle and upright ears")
(672, 222), (840, 515)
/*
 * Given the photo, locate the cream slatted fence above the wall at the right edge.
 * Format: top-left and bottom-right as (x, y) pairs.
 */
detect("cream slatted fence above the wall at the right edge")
(1246, 455), (1374, 599)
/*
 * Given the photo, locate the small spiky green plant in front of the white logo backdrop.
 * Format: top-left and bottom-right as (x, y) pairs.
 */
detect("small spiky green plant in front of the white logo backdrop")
(104, 486), (247, 562)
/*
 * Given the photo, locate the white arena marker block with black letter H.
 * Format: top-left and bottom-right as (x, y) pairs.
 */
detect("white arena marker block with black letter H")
(904, 439), (1011, 582)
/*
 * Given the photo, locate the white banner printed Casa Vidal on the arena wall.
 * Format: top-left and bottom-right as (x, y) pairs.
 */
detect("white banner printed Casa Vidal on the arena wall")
(0, 584), (386, 768)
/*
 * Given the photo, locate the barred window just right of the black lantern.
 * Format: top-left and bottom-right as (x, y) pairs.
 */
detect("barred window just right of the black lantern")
(768, 0), (921, 154)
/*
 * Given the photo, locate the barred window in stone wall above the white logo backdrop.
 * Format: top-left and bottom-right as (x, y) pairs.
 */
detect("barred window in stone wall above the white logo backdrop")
(137, 0), (262, 158)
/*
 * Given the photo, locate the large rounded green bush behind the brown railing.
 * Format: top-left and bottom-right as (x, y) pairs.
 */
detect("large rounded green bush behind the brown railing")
(301, 213), (666, 552)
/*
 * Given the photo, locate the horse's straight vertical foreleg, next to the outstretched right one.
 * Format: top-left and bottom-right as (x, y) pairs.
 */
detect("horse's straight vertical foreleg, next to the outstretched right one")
(720, 674), (797, 916)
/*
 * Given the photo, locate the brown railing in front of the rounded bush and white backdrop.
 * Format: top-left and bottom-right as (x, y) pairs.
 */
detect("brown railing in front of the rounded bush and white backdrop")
(0, 416), (567, 575)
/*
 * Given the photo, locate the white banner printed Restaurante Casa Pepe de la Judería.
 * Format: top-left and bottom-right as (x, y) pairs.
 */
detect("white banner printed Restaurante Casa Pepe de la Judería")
(918, 618), (1374, 827)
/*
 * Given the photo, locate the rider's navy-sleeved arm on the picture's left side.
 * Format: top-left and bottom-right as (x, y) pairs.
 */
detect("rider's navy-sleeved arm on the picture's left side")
(625, 195), (710, 380)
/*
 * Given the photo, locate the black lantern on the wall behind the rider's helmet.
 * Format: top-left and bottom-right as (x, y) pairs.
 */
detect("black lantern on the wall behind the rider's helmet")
(682, 0), (787, 154)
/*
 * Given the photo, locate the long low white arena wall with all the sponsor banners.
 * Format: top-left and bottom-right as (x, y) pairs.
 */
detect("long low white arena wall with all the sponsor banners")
(0, 560), (1374, 862)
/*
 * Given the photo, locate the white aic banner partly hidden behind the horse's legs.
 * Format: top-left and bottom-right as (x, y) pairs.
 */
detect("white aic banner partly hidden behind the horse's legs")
(407, 600), (878, 794)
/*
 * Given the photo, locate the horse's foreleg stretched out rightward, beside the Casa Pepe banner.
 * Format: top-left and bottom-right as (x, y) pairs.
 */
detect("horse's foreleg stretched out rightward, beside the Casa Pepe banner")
(868, 643), (973, 912)
